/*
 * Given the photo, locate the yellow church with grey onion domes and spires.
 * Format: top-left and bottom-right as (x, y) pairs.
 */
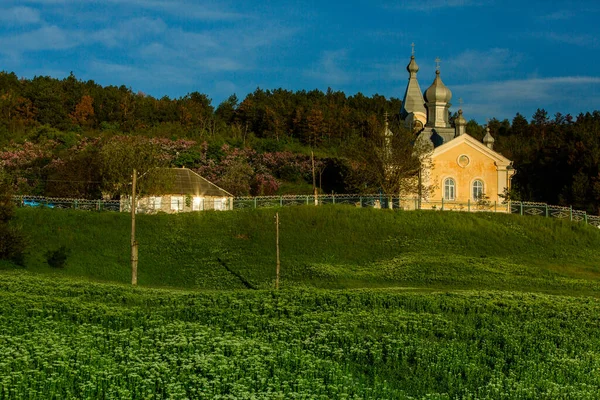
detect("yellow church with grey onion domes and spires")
(400, 45), (516, 211)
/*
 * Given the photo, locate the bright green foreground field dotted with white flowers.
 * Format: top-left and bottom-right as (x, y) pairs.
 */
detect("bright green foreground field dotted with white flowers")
(0, 271), (600, 400)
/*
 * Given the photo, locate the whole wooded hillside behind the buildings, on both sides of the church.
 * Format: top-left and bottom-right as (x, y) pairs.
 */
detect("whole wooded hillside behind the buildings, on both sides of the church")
(0, 72), (600, 214)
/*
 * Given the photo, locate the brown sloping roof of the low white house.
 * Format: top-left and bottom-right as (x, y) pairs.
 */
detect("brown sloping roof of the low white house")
(144, 168), (233, 197)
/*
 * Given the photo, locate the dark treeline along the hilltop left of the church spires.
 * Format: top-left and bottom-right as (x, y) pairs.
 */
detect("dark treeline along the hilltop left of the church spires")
(0, 73), (400, 146)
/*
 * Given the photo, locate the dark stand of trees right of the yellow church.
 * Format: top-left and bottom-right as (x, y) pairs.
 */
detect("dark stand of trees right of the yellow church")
(490, 110), (600, 214)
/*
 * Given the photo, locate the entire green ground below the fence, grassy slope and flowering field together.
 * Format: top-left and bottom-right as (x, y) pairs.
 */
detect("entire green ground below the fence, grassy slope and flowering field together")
(0, 206), (600, 399)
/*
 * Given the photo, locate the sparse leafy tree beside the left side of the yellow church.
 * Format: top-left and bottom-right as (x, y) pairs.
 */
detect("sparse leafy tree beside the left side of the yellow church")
(347, 119), (431, 195)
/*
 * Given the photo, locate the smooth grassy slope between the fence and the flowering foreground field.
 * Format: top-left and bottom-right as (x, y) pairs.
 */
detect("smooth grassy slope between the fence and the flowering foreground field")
(7, 206), (600, 296)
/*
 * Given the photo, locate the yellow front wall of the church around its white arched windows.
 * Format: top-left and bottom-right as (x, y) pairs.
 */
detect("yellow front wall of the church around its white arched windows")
(429, 143), (506, 203)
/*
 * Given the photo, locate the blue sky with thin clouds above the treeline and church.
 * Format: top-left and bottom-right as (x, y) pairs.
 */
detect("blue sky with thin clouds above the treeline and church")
(0, 0), (600, 122)
